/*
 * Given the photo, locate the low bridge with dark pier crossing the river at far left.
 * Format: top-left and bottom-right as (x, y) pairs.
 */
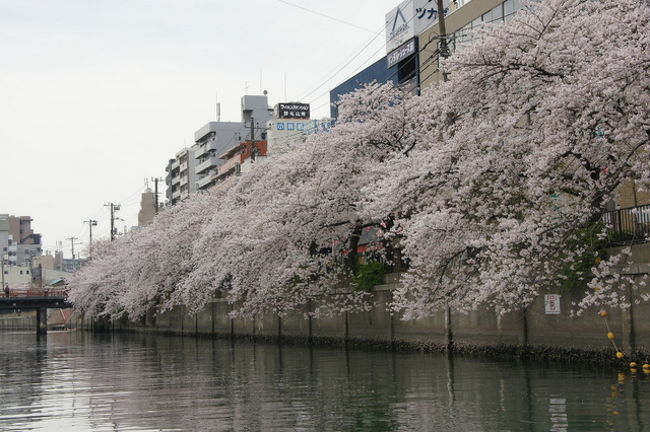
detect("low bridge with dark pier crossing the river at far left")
(0, 288), (72, 335)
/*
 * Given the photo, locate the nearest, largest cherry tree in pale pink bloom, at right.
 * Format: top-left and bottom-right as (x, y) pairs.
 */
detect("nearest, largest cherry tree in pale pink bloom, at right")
(373, 0), (650, 317)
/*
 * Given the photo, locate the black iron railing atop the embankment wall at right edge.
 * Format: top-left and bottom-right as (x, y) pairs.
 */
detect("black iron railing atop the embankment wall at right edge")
(603, 205), (650, 244)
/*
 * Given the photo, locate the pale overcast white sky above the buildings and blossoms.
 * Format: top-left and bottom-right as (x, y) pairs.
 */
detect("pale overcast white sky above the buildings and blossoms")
(0, 0), (399, 257)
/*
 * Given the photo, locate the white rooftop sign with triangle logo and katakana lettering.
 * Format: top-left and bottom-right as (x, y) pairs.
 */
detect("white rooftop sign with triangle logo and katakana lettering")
(386, 0), (450, 53)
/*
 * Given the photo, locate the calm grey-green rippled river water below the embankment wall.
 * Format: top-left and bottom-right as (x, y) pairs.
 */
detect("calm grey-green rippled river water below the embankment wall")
(0, 332), (650, 432)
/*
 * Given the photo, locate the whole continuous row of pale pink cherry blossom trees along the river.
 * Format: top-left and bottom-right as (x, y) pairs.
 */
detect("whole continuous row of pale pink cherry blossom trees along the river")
(70, 0), (650, 318)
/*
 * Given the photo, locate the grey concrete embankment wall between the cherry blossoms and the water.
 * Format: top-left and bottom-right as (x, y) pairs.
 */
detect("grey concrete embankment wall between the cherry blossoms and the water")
(73, 272), (650, 357)
